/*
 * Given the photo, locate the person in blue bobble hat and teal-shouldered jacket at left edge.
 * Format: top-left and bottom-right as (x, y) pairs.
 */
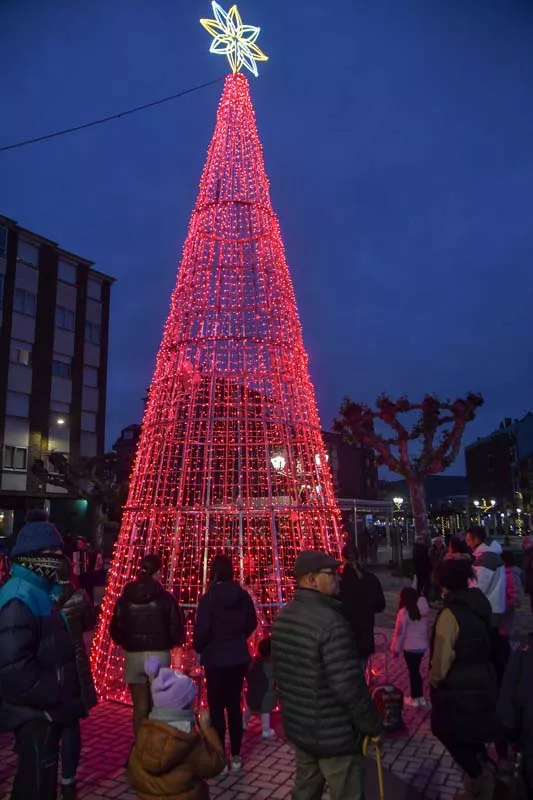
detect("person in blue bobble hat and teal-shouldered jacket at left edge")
(0, 510), (85, 800)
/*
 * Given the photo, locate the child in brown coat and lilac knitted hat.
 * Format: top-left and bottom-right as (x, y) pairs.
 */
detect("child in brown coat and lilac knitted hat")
(128, 656), (226, 800)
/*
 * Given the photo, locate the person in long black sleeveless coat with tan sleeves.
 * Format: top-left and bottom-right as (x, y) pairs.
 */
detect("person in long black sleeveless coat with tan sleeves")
(429, 556), (498, 798)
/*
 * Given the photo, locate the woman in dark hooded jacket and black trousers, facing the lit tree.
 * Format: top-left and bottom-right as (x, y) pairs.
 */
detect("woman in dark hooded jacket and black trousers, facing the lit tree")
(193, 555), (257, 772)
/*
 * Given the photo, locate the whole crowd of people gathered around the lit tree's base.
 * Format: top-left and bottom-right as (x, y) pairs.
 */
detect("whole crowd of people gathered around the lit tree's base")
(0, 512), (533, 800)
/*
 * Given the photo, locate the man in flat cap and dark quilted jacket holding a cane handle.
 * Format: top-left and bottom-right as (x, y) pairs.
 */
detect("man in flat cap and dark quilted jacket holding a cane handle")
(272, 550), (381, 800)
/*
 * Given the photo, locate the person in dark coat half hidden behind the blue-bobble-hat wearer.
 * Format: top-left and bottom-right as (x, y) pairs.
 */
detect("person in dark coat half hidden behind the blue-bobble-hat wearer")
(57, 557), (98, 800)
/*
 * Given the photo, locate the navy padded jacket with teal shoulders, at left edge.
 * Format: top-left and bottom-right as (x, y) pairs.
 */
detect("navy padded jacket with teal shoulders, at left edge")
(0, 564), (85, 730)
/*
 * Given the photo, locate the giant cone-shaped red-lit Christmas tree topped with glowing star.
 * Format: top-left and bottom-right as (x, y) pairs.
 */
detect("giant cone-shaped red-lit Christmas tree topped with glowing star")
(92, 3), (341, 699)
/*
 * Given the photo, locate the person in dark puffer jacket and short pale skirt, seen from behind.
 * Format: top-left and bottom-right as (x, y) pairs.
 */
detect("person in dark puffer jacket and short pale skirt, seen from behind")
(109, 554), (185, 734)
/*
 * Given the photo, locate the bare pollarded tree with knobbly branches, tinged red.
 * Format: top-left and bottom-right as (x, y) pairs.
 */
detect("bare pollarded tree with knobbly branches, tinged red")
(334, 393), (483, 535)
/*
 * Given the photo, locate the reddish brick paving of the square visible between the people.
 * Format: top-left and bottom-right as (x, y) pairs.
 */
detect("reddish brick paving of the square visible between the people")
(0, 577), (530, 800)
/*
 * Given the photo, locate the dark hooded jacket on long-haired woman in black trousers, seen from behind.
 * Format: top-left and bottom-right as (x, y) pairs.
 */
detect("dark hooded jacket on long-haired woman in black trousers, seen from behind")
(193, 581), (257, 668)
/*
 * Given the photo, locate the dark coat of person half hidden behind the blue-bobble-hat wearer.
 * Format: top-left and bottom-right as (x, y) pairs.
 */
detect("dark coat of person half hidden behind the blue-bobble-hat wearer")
(58, 584), (98, 712)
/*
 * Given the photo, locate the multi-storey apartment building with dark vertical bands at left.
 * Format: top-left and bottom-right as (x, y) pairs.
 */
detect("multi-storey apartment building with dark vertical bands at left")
(0, 215), (113, 536)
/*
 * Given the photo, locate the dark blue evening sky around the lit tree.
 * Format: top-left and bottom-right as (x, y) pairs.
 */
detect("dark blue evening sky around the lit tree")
(0, 0), (533, 471)
